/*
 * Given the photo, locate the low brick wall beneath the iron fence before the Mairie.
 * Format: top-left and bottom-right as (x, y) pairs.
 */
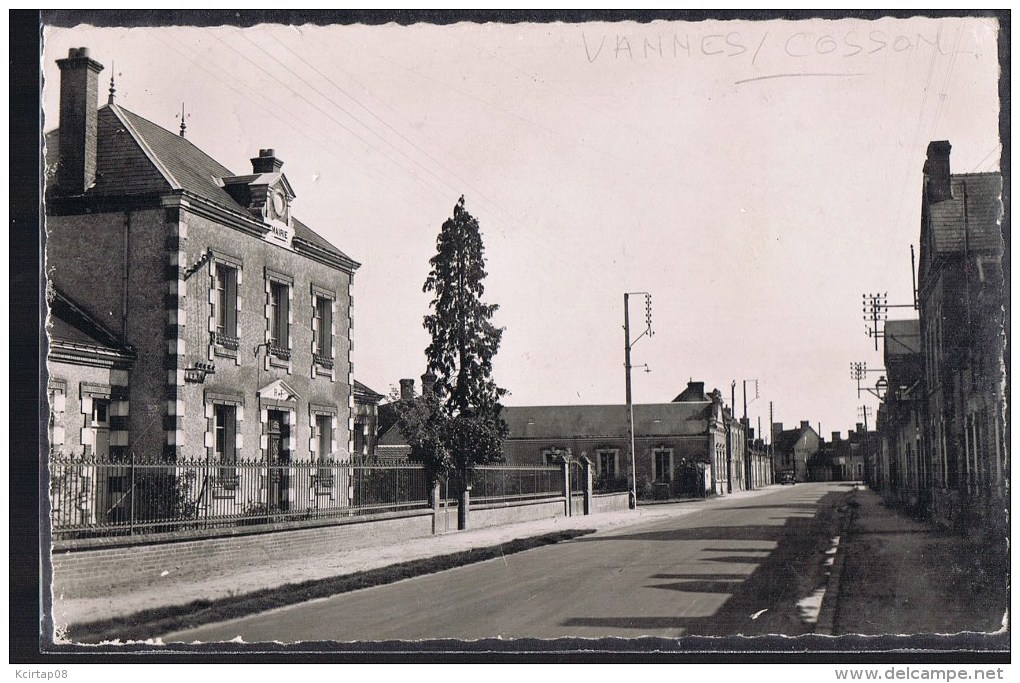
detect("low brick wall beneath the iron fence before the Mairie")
(52, 510), (432, 597)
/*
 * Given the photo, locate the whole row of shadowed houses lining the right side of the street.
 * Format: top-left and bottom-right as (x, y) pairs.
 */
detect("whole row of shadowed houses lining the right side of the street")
(873, 141), (1009, 537)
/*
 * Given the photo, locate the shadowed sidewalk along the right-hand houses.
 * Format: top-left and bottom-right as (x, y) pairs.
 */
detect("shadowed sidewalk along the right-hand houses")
(833, 488), (1009, 635)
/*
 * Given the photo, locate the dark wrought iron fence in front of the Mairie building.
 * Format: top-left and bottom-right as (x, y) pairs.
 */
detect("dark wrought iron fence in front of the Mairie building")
(50, 455), (429, 540)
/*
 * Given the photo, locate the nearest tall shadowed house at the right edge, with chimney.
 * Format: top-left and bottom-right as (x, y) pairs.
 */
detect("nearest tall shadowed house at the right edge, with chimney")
(917, 141), (1009, 535)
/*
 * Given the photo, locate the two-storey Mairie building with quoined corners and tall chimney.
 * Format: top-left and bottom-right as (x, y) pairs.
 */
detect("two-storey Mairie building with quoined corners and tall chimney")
(46, 48), (363, 500)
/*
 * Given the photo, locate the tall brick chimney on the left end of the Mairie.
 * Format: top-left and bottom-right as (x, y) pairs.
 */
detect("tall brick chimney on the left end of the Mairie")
(57, 48), (103, 195)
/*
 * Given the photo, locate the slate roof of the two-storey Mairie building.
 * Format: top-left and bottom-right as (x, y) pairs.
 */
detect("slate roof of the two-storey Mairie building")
(46, 104), (359, 268)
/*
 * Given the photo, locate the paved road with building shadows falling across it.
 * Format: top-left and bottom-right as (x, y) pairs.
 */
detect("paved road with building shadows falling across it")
(163, 483), (849, 642)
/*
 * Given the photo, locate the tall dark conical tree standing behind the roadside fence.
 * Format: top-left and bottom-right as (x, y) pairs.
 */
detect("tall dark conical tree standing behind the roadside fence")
(399, 197), (507, 525)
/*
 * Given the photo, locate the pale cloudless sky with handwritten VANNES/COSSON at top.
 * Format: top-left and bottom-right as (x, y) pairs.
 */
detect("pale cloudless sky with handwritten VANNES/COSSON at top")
(42, 17), (1001, 437)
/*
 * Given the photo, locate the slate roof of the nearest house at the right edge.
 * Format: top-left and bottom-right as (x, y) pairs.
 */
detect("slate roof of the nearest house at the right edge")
(928, 173), (1003, 254)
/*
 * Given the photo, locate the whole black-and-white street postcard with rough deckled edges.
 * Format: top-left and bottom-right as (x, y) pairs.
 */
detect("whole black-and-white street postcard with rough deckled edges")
(19, 10), (1011, 668)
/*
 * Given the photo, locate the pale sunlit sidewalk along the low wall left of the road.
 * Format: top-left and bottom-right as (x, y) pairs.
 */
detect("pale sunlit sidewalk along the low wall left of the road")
(53, 488), (770, 631)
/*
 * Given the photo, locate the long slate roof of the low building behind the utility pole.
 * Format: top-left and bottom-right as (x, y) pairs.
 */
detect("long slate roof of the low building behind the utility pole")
(503, 401), (712, 438)
